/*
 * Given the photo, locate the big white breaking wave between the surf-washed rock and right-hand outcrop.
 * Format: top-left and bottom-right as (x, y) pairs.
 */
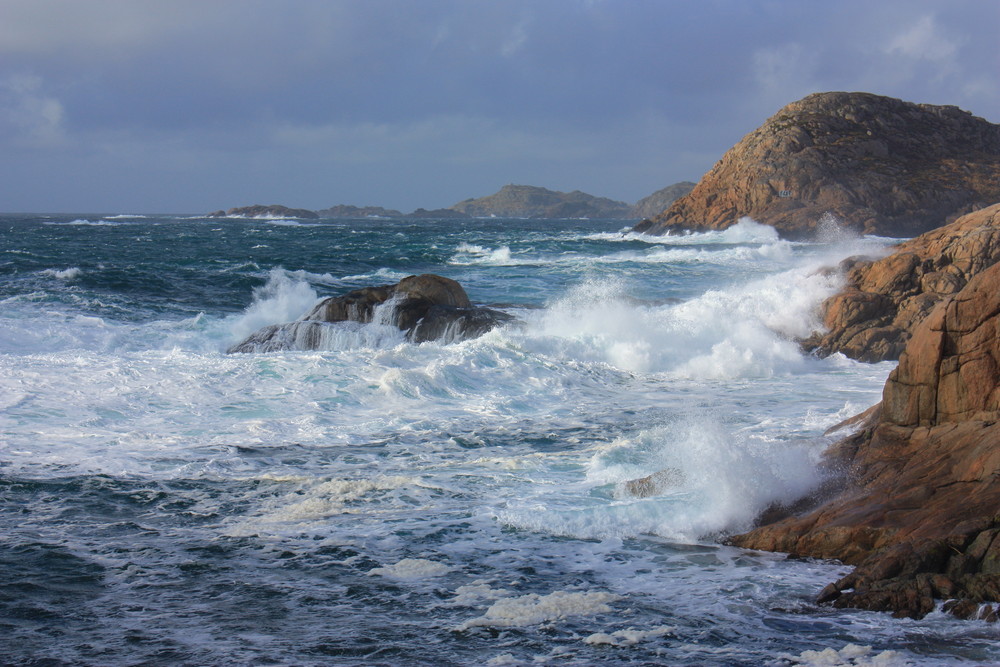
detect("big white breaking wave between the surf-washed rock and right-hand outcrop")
(528, 258), (838, 379)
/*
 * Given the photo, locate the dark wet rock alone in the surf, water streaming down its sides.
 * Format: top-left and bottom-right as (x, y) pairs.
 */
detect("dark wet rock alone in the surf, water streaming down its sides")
(226, 274), (513, 353)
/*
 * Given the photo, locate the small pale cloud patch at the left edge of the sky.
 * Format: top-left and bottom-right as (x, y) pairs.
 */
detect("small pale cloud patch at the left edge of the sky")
(0, 75), (66, 146)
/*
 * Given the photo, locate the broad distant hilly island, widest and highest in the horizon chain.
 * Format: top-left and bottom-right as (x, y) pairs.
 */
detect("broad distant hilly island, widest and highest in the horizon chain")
(451, 185), (632, 219)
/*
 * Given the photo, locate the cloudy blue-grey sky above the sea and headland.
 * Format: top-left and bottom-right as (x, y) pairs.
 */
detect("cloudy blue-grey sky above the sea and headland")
(0, 0), (1000, 213)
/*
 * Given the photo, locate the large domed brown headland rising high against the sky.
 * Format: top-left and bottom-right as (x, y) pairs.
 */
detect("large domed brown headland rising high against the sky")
(635, 93), (1000, 238)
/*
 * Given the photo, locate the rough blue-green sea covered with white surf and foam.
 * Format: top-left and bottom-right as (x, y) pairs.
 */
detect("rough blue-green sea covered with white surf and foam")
(0, 215), (1000, 665)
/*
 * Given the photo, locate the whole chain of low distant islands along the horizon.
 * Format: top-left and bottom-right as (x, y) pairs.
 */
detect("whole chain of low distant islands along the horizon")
(208, 181), (695, 220)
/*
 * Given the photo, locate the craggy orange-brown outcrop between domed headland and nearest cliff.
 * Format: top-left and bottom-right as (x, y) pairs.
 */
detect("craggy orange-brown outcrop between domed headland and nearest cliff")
(802, 204), (1000, 362)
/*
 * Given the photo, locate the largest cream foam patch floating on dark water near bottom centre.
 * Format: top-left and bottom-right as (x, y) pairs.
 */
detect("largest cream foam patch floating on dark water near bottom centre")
(455, 591), (621, 632)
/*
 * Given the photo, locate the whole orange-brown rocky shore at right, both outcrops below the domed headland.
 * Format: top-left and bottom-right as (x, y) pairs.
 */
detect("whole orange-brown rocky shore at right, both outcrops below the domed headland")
(730, 205), (1000, 621)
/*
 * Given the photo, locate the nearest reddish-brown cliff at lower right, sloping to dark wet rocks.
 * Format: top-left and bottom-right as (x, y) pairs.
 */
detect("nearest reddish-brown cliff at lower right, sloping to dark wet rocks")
(730, 264), (1000, 620)
